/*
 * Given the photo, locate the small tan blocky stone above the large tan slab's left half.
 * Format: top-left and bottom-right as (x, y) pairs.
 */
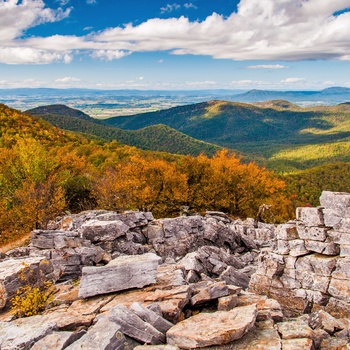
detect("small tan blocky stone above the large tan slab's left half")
(191, 282), (229, 306)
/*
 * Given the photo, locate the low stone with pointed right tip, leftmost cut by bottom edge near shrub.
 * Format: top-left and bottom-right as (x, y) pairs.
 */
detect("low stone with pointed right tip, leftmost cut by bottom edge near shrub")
(31, 331), (86, 350)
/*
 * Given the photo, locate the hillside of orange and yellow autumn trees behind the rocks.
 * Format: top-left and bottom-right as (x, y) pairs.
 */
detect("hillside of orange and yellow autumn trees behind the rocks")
(0, 105), (294, 244)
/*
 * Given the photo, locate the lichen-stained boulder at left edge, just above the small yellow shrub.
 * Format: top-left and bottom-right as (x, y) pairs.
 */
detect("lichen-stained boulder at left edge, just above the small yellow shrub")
(0, 256), (57, 309)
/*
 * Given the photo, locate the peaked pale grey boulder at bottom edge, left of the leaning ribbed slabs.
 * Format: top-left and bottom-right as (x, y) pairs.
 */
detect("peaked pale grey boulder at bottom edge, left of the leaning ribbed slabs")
(66, 318), (125, 350)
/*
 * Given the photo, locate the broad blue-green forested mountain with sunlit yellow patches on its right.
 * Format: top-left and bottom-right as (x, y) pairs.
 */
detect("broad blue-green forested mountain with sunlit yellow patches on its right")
(106, 100), (350, 172)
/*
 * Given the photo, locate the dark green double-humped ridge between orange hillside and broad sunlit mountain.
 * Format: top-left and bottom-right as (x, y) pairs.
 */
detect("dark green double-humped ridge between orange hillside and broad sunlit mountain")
(25, 105), (221, 156)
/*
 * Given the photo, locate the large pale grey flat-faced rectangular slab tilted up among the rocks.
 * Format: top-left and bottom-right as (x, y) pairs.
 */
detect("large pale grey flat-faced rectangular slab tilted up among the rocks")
(79, 253), (161, 298)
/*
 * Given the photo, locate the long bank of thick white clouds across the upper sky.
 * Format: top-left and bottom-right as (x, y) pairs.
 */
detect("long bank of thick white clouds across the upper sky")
(0, 0), (350, 64)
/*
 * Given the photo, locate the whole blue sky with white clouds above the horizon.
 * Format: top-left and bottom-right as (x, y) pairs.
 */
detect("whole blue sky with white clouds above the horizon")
(0, 0), (350, 90)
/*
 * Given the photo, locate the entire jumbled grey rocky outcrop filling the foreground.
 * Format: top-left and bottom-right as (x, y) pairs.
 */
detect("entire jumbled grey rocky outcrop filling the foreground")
(0, 196), (350, 350)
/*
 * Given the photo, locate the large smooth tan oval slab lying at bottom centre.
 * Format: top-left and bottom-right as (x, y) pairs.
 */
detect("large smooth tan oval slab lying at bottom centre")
(167, 305), (257, 349)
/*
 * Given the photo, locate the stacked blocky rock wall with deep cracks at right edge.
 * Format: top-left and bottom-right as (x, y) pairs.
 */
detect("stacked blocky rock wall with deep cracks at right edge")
(250, 191), (350, 317)
